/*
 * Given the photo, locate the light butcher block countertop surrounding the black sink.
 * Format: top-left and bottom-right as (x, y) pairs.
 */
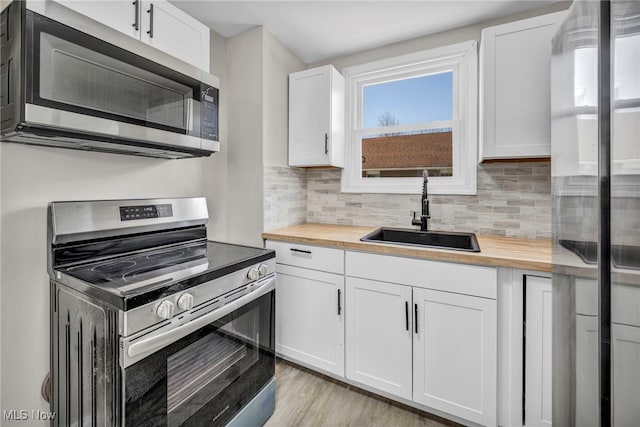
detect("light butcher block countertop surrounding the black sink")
(262, 224), (551, 272)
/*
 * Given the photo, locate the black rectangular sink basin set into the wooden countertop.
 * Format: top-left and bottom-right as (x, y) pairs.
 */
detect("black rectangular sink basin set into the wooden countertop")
(360, 227), (480, 252)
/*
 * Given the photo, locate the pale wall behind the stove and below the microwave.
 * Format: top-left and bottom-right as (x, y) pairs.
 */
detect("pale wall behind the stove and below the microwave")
(0, 29), (228, 426)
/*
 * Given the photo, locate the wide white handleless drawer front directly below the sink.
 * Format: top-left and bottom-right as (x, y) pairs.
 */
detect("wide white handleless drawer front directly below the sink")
(345, 251), (498, 299)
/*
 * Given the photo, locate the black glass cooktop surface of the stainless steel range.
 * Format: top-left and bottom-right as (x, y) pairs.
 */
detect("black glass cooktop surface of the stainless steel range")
(60, 241), (269, 295)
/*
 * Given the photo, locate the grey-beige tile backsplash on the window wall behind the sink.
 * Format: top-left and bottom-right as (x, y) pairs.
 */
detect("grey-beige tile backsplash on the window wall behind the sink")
(306, 162), (551, 238)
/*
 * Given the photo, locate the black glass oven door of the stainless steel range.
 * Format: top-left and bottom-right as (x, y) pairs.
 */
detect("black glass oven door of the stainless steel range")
(123, 277), (275, 427)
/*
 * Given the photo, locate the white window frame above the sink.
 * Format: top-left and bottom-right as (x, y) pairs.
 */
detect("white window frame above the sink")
(341, 40), (478, 195)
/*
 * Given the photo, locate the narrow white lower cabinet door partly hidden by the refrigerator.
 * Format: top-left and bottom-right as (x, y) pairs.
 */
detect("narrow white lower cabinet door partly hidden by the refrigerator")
(525, 276), (552, 427)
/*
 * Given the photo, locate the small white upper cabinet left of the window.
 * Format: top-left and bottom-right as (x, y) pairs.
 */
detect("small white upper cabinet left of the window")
(289, 65), (345, 168)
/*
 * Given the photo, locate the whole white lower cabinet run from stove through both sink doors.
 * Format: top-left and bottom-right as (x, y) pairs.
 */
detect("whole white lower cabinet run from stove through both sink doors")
(266, 241), (498, 426)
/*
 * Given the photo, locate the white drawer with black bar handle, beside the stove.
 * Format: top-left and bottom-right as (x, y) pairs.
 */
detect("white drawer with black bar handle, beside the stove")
(266, 240), (344, 274)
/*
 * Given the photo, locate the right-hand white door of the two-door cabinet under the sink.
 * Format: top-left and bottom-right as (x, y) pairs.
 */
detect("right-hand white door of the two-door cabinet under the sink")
(413, 288), (497, 426)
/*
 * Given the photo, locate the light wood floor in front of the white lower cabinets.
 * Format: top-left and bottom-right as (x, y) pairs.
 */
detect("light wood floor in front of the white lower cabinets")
(265, 360), (458, 427)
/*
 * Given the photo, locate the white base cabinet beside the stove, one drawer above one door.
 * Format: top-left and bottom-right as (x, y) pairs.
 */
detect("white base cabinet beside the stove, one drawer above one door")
(266, 241), (344, 376)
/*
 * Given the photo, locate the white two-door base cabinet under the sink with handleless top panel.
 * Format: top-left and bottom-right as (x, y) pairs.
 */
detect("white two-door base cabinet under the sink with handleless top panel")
(345, 252), (497, 426)
